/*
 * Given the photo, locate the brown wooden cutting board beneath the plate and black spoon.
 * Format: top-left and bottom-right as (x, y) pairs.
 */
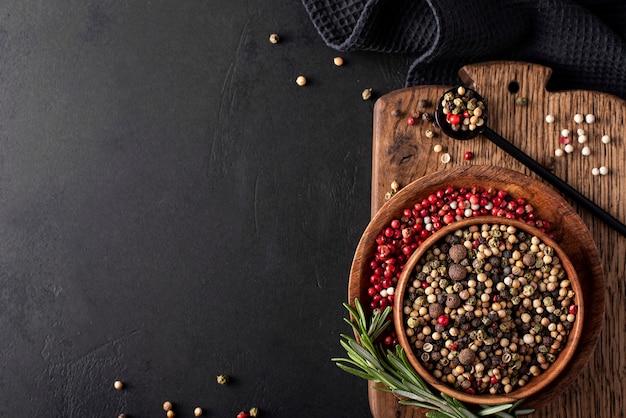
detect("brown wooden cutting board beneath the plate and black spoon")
(368, 62), (626, 418)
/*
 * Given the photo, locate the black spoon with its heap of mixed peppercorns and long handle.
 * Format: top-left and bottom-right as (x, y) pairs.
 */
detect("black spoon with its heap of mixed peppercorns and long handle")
(435, 86), (626, 236)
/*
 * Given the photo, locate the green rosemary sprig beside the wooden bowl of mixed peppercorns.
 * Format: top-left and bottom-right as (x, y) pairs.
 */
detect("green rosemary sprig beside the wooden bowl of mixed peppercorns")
(332, 299), (534, 418)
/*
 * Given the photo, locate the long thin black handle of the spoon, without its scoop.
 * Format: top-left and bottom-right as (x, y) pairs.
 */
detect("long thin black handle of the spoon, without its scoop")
(481, 126), (626, 236)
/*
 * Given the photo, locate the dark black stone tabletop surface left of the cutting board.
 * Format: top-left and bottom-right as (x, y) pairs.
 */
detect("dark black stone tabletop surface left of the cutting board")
(0, 0), (409, 418)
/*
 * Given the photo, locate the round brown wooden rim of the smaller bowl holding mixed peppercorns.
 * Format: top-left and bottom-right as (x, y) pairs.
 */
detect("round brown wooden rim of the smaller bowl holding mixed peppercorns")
(393, 216), (584, 405)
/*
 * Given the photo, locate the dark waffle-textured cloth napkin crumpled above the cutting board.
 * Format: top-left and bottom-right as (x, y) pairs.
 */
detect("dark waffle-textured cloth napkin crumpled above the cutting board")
(302, 0), (626, 99)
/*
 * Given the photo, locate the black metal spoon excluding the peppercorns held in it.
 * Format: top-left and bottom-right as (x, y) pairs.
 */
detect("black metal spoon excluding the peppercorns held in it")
(435, 88), (626, 236)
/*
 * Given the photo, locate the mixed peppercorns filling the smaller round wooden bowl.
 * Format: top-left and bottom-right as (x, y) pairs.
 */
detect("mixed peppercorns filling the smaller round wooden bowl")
(403, 224), (578, 394)
